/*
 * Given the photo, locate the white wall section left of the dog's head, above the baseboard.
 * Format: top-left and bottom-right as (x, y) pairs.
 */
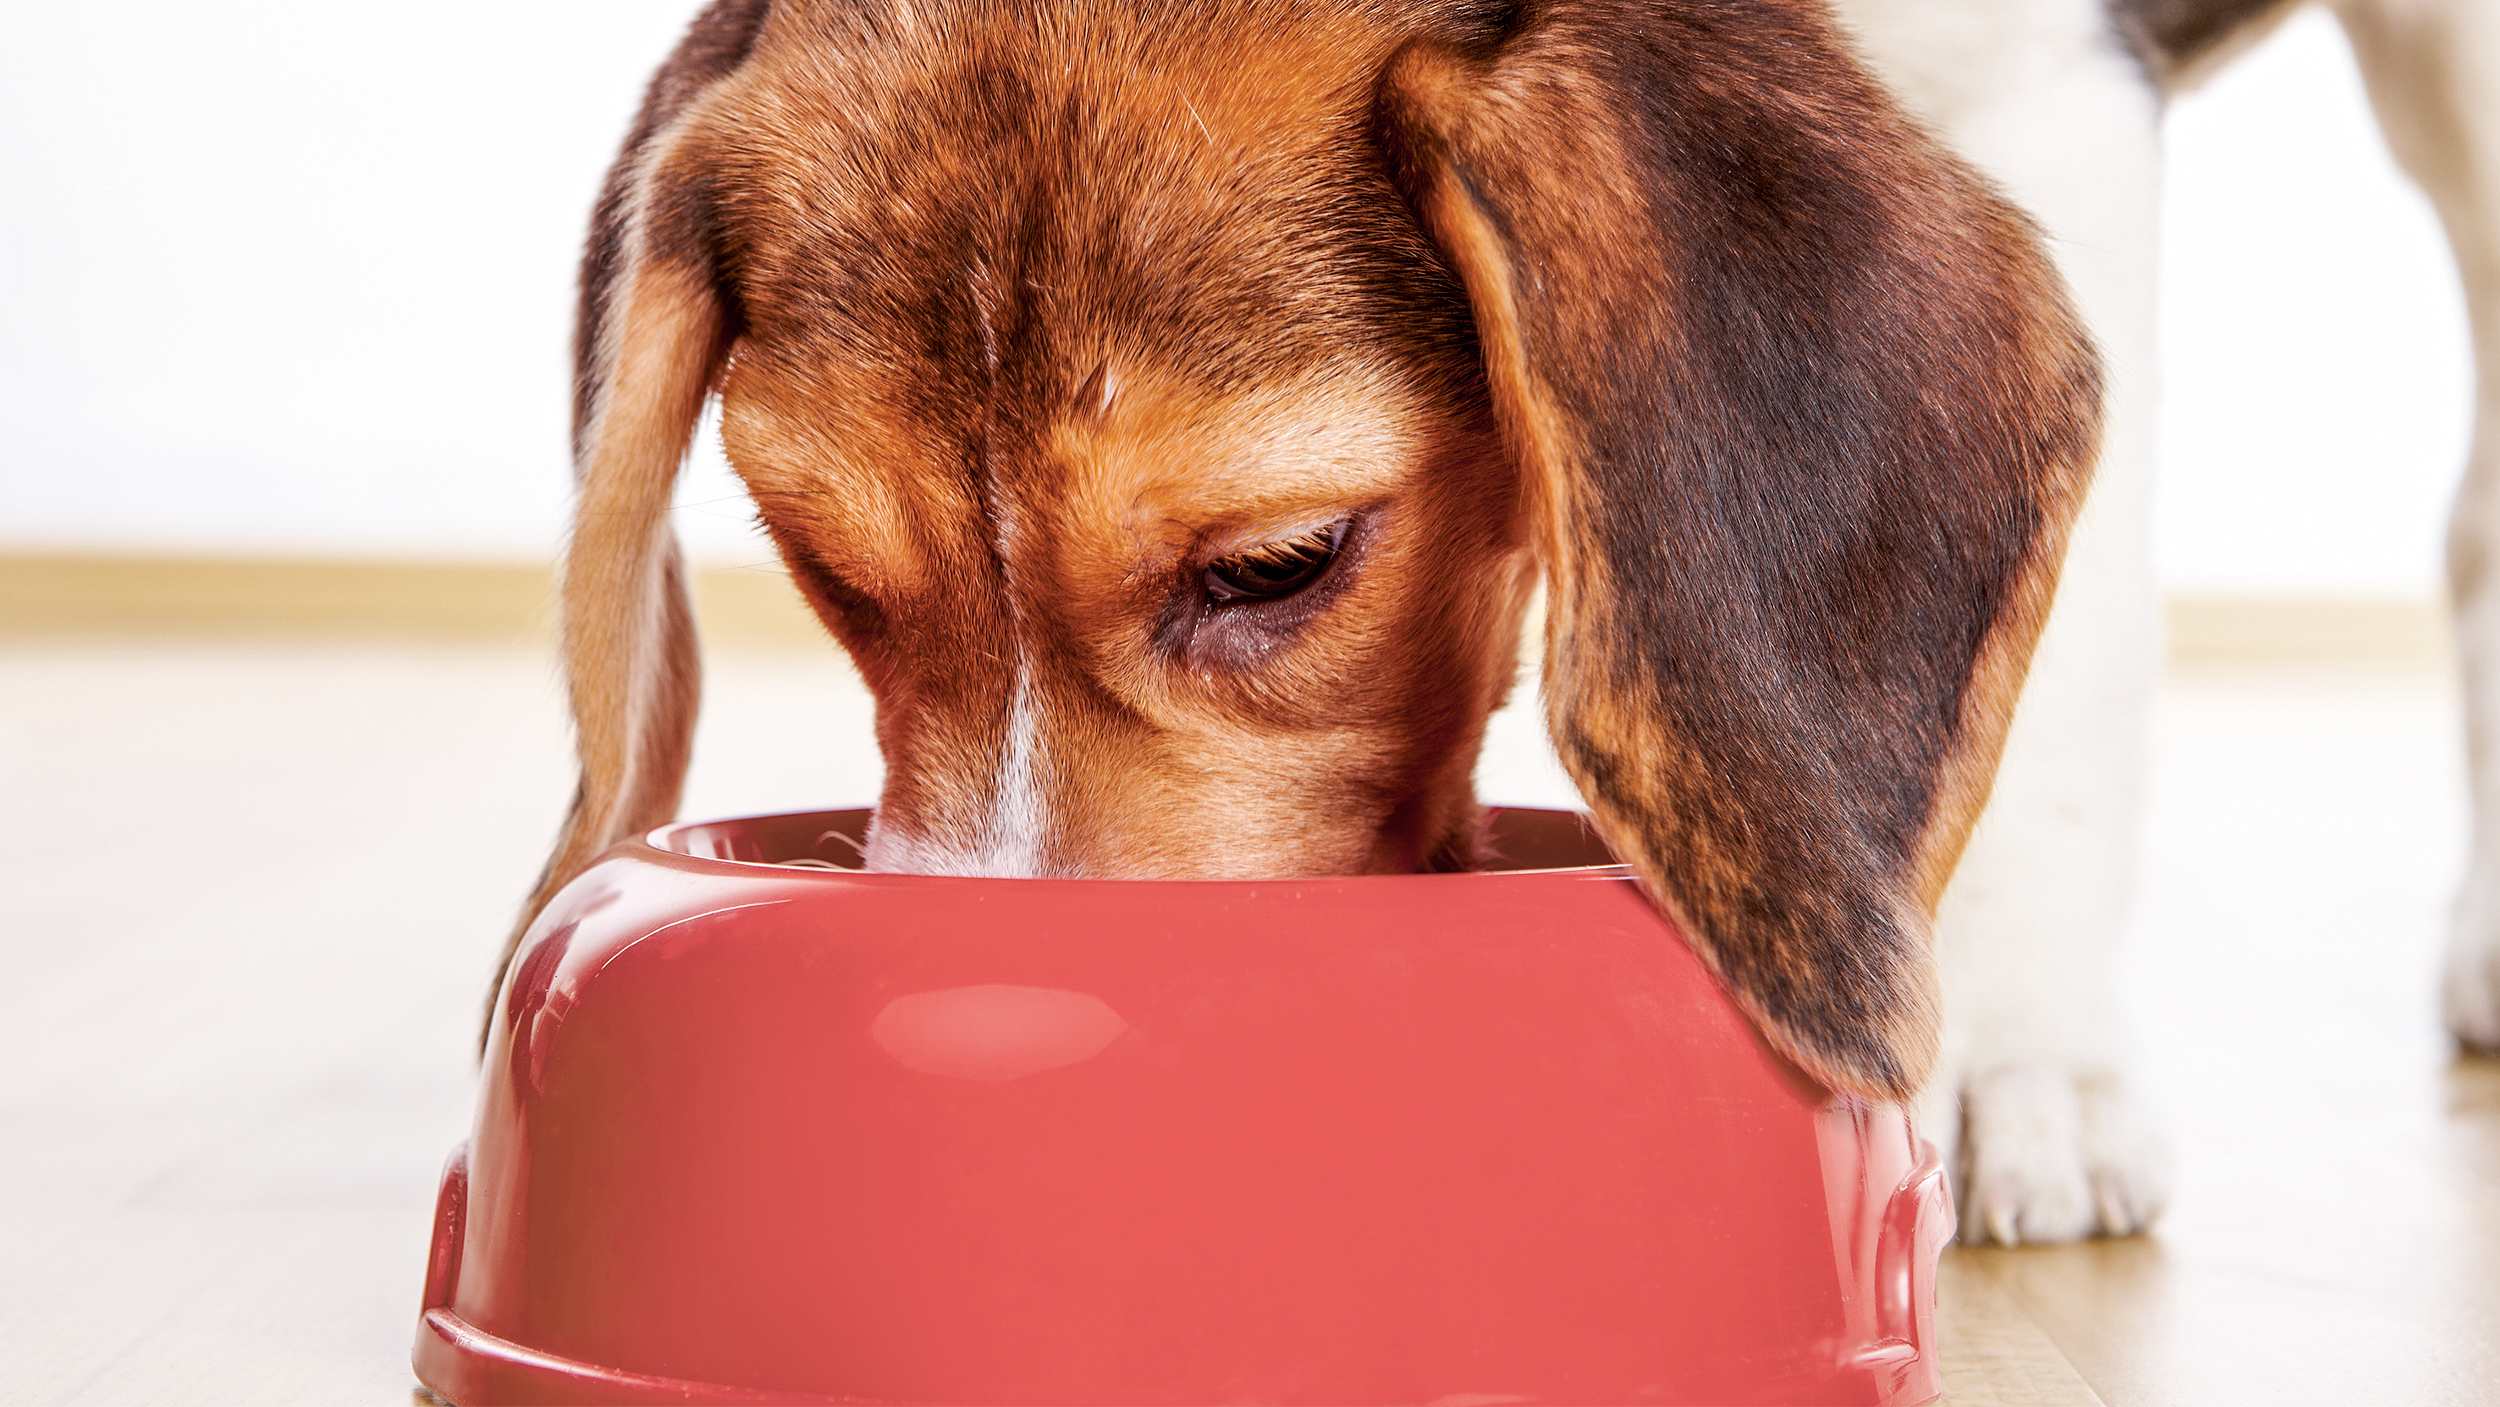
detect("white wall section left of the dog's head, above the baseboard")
(0, 0), (760, 557)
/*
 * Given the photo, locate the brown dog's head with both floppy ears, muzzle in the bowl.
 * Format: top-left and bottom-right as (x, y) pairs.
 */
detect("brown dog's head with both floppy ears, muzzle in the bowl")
(517, 0), (2095, 1095)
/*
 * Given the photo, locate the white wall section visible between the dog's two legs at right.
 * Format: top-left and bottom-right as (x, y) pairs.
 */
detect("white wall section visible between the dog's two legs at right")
(2160, 10), (2473, 595)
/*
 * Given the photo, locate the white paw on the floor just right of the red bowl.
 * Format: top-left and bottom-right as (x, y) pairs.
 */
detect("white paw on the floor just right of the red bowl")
(1960, 1065), (2170, 1245)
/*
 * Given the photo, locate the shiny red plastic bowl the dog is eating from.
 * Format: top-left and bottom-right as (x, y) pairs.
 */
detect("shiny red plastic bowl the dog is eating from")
(415, 812), (1953, 1407)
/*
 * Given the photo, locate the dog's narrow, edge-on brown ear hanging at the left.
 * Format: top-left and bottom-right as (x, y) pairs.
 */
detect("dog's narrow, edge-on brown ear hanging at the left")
(488, 0), (770, 1002)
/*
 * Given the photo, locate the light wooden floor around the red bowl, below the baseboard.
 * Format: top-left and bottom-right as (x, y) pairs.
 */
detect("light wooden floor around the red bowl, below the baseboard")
(0, 640), (2500, 1407)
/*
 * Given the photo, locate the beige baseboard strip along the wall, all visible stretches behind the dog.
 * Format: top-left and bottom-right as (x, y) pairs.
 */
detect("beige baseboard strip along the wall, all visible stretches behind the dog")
(0, 552), (2450, 667)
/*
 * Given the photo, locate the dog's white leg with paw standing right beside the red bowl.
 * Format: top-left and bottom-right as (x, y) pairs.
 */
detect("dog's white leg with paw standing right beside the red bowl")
(1840, 0), (2168, 1242)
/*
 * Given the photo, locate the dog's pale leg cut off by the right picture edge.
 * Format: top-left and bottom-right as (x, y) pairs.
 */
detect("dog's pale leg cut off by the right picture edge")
(2335, 0), (2500, 1050)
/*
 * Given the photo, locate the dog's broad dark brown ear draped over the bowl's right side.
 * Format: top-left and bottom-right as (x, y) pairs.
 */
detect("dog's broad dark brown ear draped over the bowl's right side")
(1380, 0), (2098, 1097)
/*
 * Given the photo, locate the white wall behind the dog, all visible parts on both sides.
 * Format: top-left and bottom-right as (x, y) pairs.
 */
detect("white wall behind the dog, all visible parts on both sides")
(0, 0), (2468, 592)
